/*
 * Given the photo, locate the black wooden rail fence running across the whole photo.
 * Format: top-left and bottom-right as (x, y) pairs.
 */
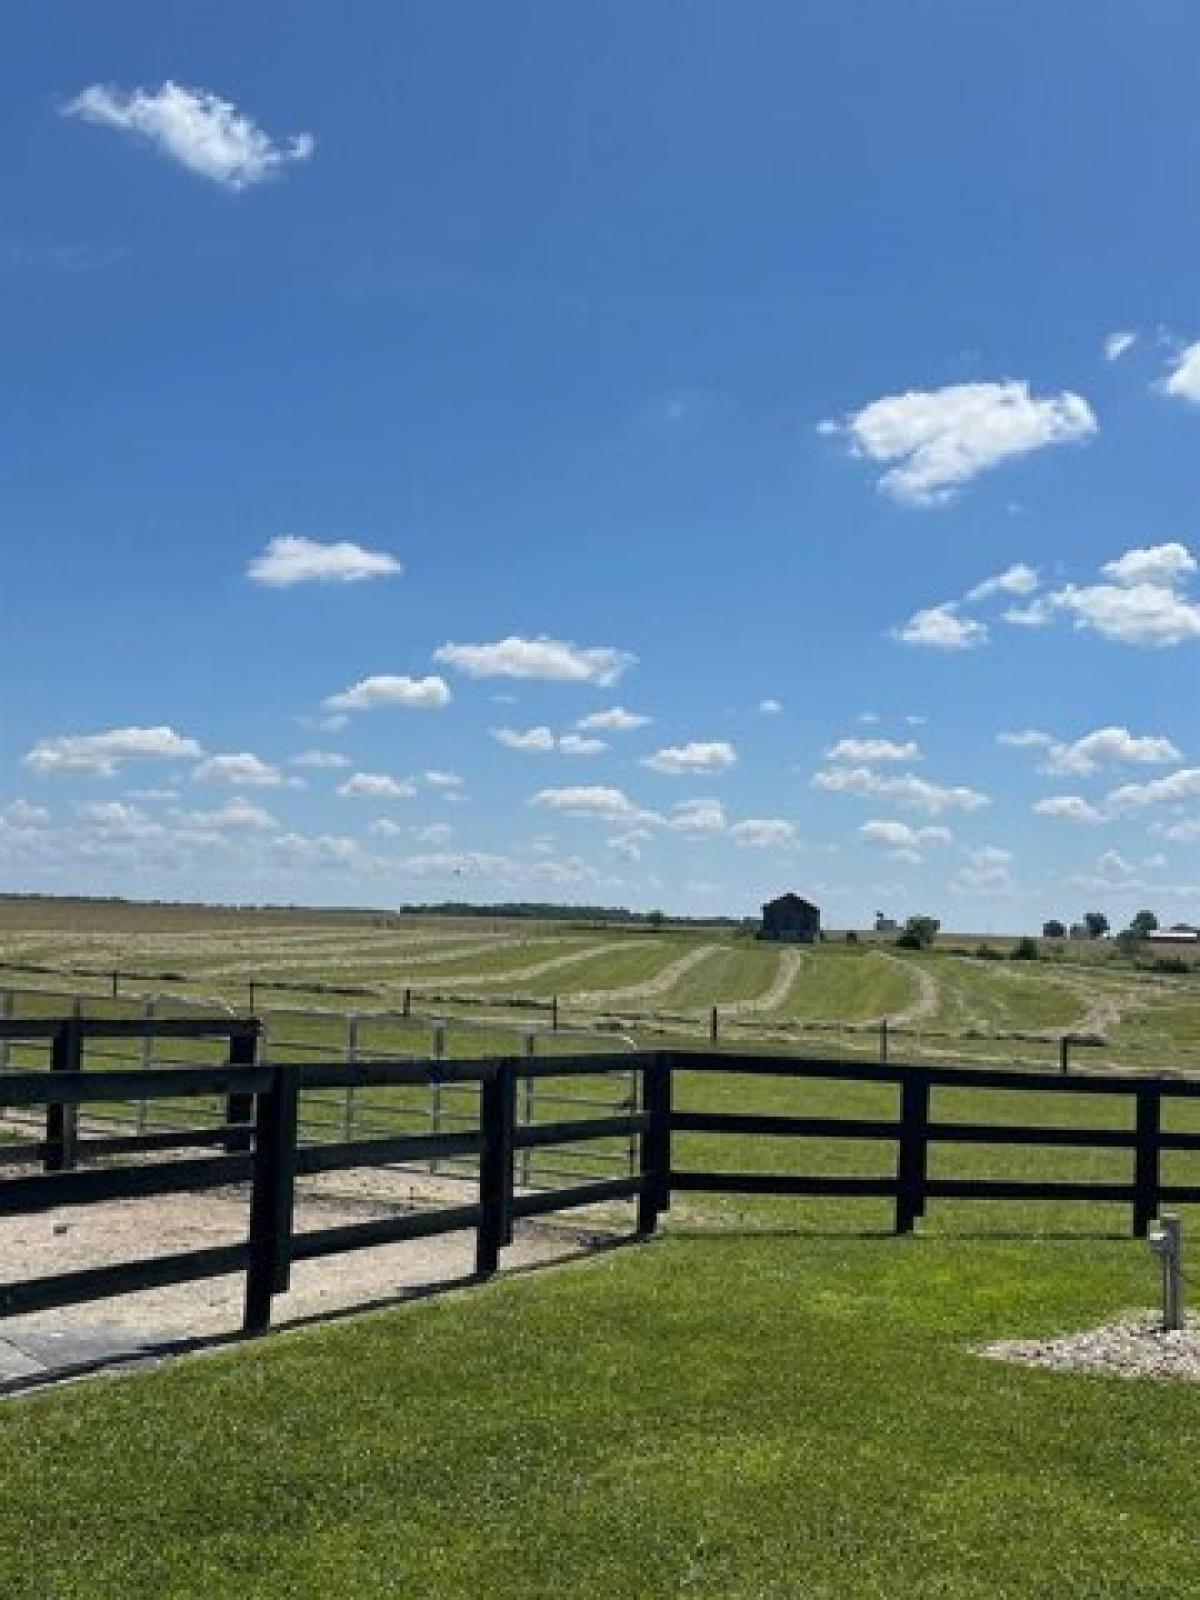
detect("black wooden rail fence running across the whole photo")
(0, 1018), (1200, 1333)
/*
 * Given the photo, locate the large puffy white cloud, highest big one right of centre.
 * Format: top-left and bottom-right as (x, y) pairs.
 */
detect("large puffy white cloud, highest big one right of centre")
(822, 379), (1096, 506)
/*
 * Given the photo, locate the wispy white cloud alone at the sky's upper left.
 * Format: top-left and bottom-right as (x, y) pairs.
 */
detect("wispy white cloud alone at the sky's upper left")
(62, 78), (315, 190)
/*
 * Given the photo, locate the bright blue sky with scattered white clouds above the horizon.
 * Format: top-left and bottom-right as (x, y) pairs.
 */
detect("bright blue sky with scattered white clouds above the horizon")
(0, 0), (1200, 931)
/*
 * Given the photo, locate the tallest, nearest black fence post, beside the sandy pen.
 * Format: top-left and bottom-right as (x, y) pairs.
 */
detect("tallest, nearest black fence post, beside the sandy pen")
(242, 1066), (296, 1333)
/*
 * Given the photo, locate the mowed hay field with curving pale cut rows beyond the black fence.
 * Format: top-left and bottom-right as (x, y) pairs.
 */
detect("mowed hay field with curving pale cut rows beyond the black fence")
(0, 899), (1200, 1069)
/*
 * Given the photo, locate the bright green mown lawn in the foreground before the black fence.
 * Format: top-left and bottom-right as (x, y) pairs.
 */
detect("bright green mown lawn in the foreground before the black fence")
(0, 1232), (1200, 1600)
